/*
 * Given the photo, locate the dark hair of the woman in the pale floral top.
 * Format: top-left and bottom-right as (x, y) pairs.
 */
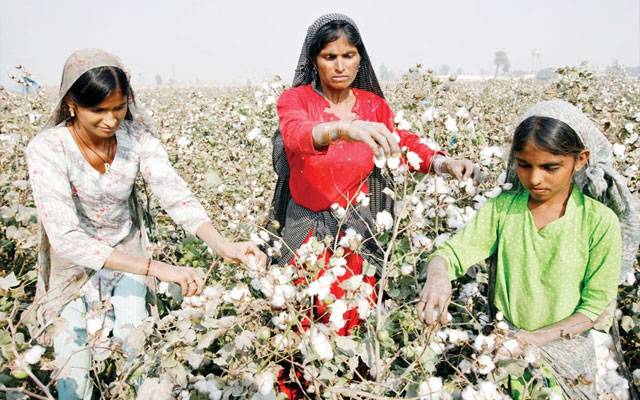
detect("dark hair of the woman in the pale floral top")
(61, 66), (135, 120)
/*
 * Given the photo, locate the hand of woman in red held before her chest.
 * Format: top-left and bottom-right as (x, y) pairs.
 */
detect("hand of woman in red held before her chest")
(339, 120), (400, 157)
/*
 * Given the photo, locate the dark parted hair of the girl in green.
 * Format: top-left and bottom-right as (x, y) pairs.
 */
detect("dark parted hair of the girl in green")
(511, 116), (585, 157)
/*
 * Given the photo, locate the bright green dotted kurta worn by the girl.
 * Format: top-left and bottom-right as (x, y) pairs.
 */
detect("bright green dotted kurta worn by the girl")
(433, 187), (622, 331)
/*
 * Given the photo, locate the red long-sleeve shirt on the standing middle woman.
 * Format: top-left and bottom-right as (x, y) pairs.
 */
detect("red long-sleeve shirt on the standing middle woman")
(278, 85), (438, 212)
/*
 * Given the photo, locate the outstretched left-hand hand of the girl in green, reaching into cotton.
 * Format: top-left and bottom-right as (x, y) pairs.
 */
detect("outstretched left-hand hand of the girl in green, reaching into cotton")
(417, 257), (451, 325)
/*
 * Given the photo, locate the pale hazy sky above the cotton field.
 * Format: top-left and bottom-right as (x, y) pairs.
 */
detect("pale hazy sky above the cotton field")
(0, 0), (640, 85)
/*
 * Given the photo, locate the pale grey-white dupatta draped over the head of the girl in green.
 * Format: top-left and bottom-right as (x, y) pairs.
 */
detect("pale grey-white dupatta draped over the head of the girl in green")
(507, 99), (640, 281)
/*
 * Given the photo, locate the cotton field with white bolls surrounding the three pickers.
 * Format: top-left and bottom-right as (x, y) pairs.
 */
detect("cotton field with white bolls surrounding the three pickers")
(0, 66), (640, 400)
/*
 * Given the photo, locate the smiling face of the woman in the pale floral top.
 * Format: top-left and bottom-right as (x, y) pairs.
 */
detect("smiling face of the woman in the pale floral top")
(68, 90), (128, 139)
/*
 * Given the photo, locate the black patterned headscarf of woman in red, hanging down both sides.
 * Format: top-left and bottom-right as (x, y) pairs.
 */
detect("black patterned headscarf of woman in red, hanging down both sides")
(269, 14), (393, 266)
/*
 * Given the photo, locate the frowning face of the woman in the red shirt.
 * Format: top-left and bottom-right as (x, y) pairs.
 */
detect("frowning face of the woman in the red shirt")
(316, 35), (360, 91)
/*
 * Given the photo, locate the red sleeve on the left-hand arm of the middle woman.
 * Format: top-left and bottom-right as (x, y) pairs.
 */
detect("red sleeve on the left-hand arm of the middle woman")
(278, 89), (326, 154)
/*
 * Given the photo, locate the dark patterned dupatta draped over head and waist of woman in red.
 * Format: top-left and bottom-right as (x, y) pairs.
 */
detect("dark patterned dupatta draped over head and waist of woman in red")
(269, 14), (393, 264)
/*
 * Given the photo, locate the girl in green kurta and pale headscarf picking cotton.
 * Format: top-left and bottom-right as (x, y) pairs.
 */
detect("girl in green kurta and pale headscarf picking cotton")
(418, 100), (638, 398)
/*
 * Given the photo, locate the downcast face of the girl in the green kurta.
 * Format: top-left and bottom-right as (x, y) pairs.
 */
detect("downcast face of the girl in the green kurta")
(514, 140), (589, 203)
